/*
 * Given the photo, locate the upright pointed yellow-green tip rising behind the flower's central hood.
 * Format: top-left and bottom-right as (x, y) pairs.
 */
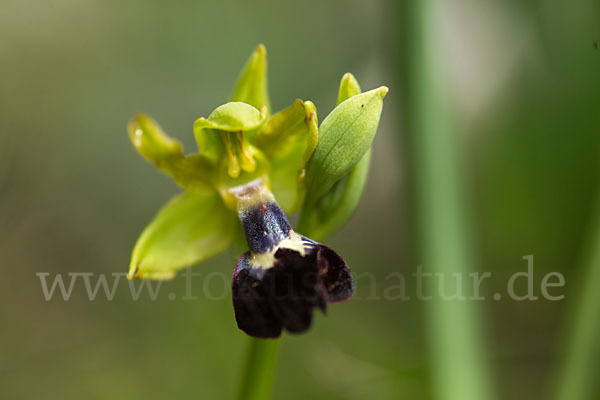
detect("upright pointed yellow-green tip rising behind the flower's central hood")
(231, 44), (271, 110)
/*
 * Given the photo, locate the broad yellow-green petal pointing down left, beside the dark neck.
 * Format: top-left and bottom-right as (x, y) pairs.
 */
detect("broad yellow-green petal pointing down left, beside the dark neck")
(128, 192), (237, 279)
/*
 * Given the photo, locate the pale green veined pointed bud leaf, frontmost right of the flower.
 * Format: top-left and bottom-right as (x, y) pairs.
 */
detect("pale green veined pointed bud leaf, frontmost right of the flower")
(306, 86), (388, 202)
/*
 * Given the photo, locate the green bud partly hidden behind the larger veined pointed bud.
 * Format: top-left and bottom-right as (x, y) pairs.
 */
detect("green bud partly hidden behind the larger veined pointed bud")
(298, 73), (371, 241)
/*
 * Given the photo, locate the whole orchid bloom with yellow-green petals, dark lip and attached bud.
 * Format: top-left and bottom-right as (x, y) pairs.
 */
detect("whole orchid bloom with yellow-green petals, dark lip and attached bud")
(127, 45), (388, 337)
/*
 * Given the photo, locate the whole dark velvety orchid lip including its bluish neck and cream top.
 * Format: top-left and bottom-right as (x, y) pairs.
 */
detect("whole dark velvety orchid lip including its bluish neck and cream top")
(232, 181), (355, 338)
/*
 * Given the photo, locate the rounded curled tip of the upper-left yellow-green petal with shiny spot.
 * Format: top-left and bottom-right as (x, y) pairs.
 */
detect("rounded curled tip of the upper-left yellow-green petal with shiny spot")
(127, 114), (183, 164)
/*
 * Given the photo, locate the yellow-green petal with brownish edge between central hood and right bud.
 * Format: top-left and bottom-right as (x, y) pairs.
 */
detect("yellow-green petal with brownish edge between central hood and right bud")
(249, 100), (318, 213)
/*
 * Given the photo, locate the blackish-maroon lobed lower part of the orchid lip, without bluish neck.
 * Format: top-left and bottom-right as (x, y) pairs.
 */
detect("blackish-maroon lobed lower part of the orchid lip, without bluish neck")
(232, 237), (354, 337)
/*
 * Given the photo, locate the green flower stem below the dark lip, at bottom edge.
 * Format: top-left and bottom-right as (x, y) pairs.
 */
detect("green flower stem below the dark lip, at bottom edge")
(238, 338), (279, 400)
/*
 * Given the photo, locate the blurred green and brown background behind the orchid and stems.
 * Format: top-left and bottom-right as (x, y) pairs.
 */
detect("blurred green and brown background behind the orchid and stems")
(0, 0), (600, 400)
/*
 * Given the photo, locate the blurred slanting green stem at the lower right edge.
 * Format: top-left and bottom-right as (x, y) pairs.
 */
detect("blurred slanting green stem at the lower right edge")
(556, 198), (600, 400)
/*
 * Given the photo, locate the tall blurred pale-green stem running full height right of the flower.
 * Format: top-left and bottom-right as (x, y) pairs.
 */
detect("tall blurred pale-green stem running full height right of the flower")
(403, 0), (494, 400)
